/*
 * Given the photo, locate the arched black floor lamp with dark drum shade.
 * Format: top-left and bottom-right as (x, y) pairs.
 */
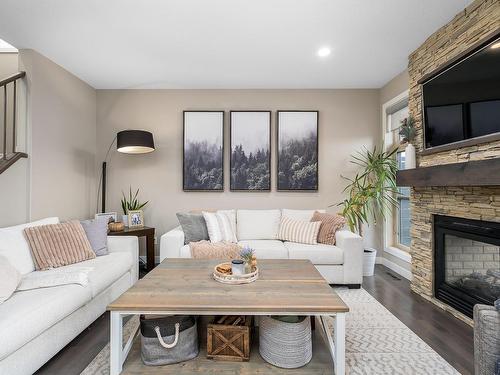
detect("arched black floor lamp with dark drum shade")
(97, 130), (155, 214)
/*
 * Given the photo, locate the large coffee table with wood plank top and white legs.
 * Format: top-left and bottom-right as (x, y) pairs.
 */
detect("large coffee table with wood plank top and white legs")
(108, 259), (349, 375)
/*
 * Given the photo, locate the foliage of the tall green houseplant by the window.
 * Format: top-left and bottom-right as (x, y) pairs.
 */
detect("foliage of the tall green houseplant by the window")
(339, 147), (399, 234)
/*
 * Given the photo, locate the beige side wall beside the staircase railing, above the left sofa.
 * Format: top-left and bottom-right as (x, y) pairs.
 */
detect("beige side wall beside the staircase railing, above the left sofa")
(19, 50), (96, 220)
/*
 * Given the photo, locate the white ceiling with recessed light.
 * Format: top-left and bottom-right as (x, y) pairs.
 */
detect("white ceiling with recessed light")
(0, 0), (471, 89)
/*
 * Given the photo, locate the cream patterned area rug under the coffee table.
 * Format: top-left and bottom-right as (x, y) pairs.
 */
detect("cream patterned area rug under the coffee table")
(82, 288), (459, 375)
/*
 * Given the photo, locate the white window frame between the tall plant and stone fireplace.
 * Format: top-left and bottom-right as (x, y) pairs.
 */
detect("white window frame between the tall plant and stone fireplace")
(382, 90), (411, 261)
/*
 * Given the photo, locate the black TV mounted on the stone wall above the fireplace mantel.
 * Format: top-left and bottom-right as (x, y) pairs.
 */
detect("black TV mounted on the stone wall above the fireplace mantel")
(423, 35), (500, 149)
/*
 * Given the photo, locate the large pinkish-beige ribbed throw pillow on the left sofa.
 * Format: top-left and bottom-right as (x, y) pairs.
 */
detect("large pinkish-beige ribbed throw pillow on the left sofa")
(24, 220), (95, 270)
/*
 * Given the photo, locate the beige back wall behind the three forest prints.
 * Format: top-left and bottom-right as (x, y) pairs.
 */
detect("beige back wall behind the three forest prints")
(97, 90), (381, 254)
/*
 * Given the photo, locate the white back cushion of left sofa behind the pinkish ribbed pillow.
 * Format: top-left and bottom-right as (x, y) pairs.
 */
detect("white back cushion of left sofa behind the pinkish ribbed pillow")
(0, 217), (59, 275)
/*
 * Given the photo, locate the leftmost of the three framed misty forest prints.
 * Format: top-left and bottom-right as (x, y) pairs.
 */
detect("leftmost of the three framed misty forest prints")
(183, 111), (224, 191)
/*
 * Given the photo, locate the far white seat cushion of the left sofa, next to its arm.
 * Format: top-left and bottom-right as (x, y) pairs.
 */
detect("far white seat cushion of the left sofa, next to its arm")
(57, 252), (133, 298)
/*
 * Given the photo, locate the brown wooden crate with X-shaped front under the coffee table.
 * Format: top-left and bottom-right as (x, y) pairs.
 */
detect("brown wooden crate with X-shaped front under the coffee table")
(207, 315), (252, 362)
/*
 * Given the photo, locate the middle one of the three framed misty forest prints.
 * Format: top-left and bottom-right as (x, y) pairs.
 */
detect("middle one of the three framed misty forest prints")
(230, 111), (271, 191)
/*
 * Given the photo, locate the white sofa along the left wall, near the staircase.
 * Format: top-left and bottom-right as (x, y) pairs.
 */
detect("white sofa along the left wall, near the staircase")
(0, 219), (139, 375)
